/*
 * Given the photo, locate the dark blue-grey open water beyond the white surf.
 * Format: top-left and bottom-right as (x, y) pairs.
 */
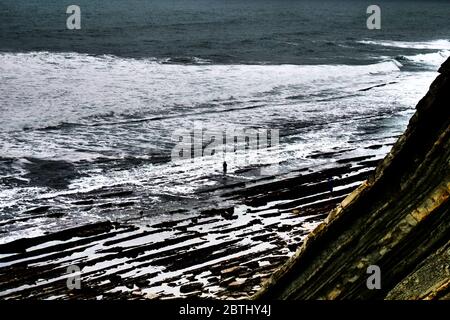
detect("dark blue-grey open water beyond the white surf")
(0, 0), (450, 65)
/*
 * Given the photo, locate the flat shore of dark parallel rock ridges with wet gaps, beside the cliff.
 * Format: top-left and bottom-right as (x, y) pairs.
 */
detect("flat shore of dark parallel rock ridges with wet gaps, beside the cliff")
(0, 141), (393, 299)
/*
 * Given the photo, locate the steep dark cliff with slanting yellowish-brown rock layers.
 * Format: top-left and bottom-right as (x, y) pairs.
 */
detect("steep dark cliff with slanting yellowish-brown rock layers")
(254, 59), (450, 299)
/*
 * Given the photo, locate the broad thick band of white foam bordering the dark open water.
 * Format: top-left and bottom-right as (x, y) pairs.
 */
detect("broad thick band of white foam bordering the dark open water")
(0, 52), (398, 131)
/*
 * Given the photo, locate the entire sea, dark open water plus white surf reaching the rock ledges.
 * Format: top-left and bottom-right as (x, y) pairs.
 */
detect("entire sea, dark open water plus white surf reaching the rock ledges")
(0, 0), (450, 243)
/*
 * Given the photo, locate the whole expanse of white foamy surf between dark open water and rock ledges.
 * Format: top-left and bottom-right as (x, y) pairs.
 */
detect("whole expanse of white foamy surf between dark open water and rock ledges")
(0, 52), (435, 236)
